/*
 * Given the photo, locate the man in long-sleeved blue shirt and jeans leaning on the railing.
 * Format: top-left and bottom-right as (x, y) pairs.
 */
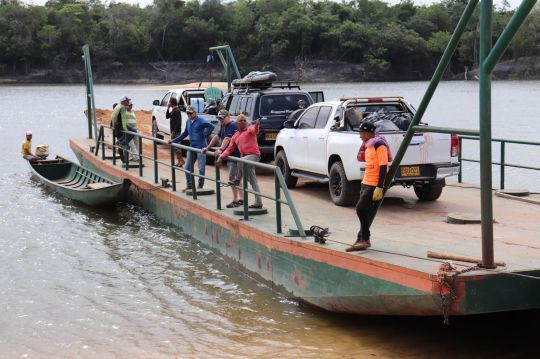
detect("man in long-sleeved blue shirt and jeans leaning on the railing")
(169, 106), (214, 192)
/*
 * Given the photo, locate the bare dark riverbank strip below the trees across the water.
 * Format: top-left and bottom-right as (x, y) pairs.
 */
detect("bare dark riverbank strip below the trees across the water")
(0, 57), (540, 84)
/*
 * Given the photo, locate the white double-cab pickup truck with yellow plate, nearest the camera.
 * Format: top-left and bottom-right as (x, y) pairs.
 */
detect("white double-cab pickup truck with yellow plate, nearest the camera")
(274, 97), (459, 206)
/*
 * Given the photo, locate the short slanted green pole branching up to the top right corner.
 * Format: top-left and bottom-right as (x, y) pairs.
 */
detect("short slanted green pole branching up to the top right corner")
(482, 0), (536, 73)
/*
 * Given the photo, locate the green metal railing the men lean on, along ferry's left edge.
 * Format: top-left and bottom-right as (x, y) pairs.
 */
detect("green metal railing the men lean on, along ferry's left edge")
(94, 125), (306, 238)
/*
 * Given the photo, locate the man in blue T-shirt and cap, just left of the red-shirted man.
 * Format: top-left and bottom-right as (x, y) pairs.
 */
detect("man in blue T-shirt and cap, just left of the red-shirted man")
(203, 109), (244, 208)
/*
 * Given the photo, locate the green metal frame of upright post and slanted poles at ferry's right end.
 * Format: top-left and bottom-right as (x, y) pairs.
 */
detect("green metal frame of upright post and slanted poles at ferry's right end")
(373, 0), (536, 268)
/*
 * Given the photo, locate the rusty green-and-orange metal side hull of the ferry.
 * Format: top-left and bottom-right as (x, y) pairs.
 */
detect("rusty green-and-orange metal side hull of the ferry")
(70, 141), (540, 316)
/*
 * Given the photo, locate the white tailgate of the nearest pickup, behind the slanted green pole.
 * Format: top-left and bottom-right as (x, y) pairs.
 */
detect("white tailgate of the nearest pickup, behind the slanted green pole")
(381, 132), (451, 165)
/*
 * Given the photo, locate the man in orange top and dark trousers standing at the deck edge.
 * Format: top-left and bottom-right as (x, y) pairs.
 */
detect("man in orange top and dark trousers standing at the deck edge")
(346, 122), (390, 252)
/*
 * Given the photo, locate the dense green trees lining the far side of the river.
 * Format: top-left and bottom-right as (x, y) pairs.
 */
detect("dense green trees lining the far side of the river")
(0, 0), (540, 77)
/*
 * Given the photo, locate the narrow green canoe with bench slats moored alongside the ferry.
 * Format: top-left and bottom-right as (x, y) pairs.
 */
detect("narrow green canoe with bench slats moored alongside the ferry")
(28, 157), (125, 207)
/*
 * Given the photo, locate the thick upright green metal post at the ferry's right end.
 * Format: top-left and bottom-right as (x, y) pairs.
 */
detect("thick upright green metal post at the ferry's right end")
(479, 0), (495, 268)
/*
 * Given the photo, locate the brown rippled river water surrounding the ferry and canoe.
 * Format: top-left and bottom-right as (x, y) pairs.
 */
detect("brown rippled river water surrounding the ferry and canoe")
(0, 81), (540, 358)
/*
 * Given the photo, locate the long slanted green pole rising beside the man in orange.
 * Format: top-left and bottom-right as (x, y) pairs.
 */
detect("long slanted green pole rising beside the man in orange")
(372, 0), (479, 221)
